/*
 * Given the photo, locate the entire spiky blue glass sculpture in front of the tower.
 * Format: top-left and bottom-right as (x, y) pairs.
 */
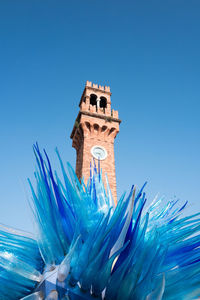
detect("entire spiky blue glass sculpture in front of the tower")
(0, 144), (200, 300)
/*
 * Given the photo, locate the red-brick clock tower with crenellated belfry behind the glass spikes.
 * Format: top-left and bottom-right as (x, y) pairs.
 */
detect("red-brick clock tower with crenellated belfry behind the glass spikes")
(70, 81), (121, 203)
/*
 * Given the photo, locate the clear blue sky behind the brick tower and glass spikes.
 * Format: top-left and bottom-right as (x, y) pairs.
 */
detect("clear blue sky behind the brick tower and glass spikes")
(0, 0), (200, 232)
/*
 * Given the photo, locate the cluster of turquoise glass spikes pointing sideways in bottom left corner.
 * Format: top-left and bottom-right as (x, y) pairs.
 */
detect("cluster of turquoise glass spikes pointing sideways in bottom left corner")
(0, 226), (43, 300)
